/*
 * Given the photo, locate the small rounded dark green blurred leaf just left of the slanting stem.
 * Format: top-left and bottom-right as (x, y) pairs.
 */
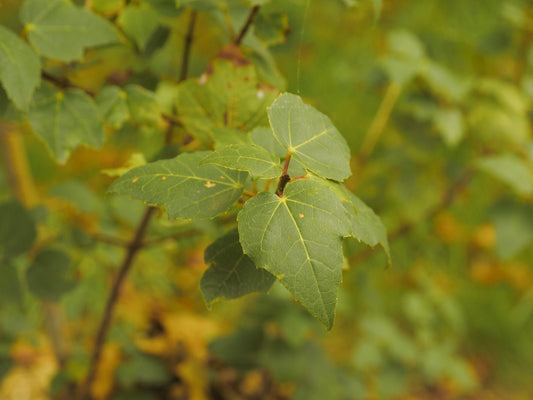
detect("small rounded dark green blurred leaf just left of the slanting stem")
(26, 249), (76, 301)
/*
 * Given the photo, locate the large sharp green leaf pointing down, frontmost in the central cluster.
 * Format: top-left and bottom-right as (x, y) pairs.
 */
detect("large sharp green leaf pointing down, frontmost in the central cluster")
(237, 179), (350, 329)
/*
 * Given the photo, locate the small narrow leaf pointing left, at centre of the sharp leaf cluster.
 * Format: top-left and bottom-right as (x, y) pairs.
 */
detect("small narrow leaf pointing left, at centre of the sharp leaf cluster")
(200, 144), (282, 179)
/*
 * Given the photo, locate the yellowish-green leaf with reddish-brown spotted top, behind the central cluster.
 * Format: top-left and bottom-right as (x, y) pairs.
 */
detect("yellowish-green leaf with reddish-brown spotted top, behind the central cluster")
(176, 60), (275, 143)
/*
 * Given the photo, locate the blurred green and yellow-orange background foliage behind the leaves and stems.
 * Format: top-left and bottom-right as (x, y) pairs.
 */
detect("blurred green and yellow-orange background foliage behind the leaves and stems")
(0, 0), (533, 400)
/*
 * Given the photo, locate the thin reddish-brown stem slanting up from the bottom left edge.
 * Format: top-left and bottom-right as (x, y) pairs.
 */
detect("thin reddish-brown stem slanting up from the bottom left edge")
(77, 207), (156, 400)
